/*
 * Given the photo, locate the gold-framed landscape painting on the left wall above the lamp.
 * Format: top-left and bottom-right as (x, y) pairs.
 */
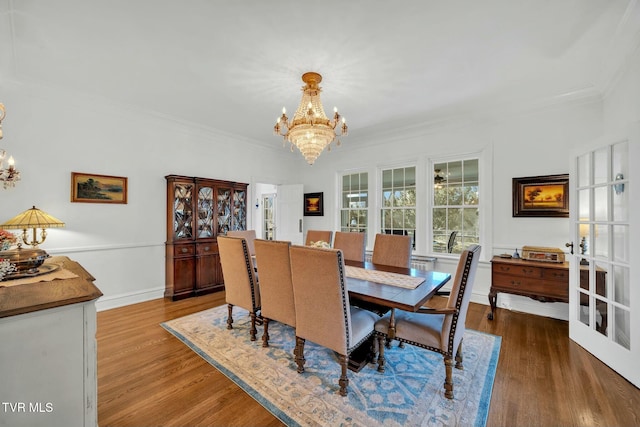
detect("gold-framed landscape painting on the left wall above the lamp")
(71, 172), (127, 204)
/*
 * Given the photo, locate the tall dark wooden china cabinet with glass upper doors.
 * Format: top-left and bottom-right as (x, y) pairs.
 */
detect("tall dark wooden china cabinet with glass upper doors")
(164, 175), (248, 300)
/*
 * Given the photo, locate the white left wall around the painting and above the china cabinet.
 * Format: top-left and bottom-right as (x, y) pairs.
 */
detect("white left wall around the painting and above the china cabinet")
(0, 82), (300, 309)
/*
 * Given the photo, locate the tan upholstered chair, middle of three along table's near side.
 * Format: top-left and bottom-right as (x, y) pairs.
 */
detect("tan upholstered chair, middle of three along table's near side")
(255, 239), (296, 347)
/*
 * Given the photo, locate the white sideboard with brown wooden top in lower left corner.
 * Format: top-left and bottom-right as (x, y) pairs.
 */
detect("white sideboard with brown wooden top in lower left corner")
(0, 256), (102, 427)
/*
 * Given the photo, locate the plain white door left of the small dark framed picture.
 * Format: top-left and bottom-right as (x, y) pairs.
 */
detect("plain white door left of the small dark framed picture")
(275, 184), (304, 245)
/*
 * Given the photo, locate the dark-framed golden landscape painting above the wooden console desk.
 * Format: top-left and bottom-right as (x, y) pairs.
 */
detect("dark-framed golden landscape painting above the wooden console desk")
(513, 174), (569, 218)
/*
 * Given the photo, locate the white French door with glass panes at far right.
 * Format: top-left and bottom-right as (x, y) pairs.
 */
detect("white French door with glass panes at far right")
(569, 136), (640, 386)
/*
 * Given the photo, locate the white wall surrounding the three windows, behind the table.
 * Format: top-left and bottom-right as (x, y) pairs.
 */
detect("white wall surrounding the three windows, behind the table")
(296, 98), (603, 319)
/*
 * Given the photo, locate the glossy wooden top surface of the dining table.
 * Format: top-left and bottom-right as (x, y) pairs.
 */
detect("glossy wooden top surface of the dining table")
(345, 261), (451, 311)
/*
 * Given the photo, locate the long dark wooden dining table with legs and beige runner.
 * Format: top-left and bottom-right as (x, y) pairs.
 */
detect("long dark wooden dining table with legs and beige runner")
(345, 260), (451, 372)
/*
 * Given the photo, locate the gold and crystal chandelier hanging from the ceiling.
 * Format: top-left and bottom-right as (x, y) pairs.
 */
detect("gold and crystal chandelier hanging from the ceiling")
(273, 72), (347, 165)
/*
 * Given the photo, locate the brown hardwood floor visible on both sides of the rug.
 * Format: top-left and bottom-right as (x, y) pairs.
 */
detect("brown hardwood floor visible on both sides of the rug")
(97, 292), (640, 427)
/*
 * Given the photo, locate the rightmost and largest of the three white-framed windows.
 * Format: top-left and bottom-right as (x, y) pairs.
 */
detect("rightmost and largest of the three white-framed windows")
(432, 159), (480, 254)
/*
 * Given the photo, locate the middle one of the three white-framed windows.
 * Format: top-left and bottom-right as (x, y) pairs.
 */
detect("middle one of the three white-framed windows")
(380, 166), (416, 249)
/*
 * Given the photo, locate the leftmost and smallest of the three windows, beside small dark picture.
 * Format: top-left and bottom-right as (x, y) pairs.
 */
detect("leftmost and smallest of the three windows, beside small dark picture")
(340, 172), (369, 237)
